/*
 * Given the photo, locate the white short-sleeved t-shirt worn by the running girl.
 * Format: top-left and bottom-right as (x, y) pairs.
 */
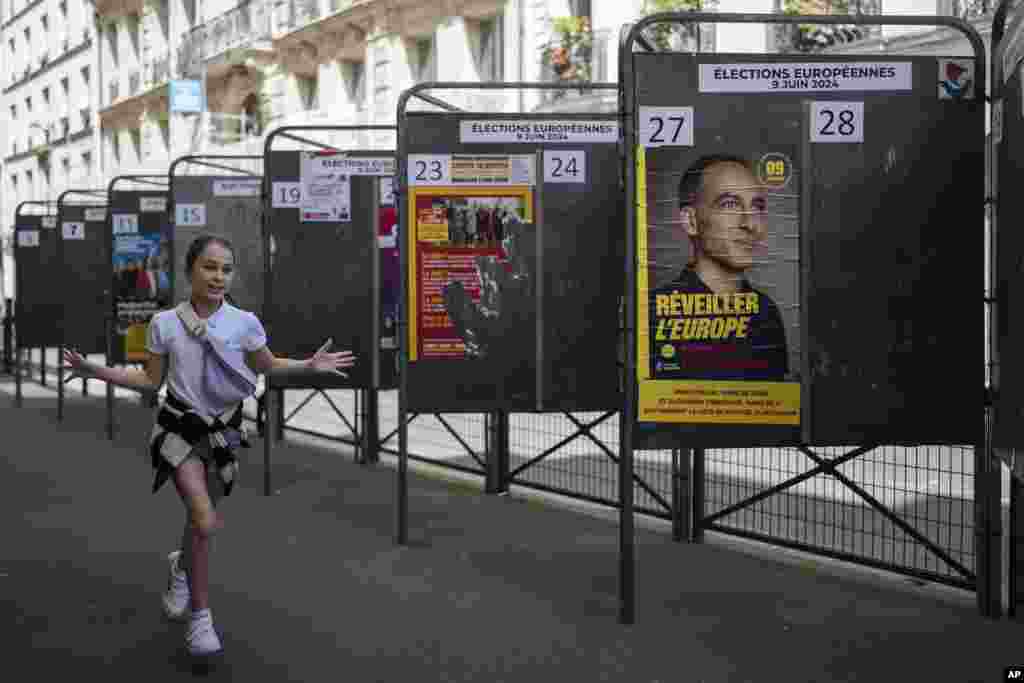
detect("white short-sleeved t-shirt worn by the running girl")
(145, 301), (266, 417)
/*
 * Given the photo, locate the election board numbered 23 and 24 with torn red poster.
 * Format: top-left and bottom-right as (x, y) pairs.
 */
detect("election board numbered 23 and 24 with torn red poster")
(402, 113), (625, 412)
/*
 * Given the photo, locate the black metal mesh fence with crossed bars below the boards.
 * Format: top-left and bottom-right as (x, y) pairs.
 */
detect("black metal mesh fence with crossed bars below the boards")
(262, 382), (976, 589)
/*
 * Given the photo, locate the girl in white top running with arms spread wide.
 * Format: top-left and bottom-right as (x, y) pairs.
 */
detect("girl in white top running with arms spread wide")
(63, 234), (355, 656)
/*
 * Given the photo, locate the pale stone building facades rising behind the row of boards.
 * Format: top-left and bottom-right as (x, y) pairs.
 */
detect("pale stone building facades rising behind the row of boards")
(0, 0), (990, 296)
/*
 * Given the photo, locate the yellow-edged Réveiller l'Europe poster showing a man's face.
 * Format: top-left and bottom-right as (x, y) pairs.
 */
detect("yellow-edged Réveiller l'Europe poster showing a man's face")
(636, 146), (801, 426)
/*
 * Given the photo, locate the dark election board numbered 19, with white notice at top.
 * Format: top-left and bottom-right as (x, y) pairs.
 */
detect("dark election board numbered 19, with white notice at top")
(264, 150), (400, 389)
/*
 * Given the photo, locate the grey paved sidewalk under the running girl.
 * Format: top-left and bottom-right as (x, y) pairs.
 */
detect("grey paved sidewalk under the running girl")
(0, 377), (1024, 683)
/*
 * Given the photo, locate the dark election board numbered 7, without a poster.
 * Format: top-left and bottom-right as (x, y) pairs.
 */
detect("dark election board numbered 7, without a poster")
(56, 204), (114, 353)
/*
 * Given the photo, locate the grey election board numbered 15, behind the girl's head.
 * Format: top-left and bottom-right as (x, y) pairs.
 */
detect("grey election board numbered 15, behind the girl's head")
(169, 175), (264, 316)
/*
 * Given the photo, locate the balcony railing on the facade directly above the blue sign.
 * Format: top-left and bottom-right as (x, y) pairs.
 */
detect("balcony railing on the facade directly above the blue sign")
(178, 0), (270, 76)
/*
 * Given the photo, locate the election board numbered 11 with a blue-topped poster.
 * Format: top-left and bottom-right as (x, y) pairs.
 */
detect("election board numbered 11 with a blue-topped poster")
(109, 190), (173, 364)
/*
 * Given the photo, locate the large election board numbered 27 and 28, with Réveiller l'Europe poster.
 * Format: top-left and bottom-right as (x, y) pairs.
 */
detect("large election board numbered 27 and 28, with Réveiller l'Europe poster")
(631, 53), (984, 447)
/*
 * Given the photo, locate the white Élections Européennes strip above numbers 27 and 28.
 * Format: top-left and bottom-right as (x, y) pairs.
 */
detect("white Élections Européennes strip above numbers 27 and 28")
(699, 61), (913, 93)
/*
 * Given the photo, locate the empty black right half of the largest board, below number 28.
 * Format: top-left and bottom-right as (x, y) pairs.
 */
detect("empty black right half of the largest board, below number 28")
(805, 88), (985, 443)
